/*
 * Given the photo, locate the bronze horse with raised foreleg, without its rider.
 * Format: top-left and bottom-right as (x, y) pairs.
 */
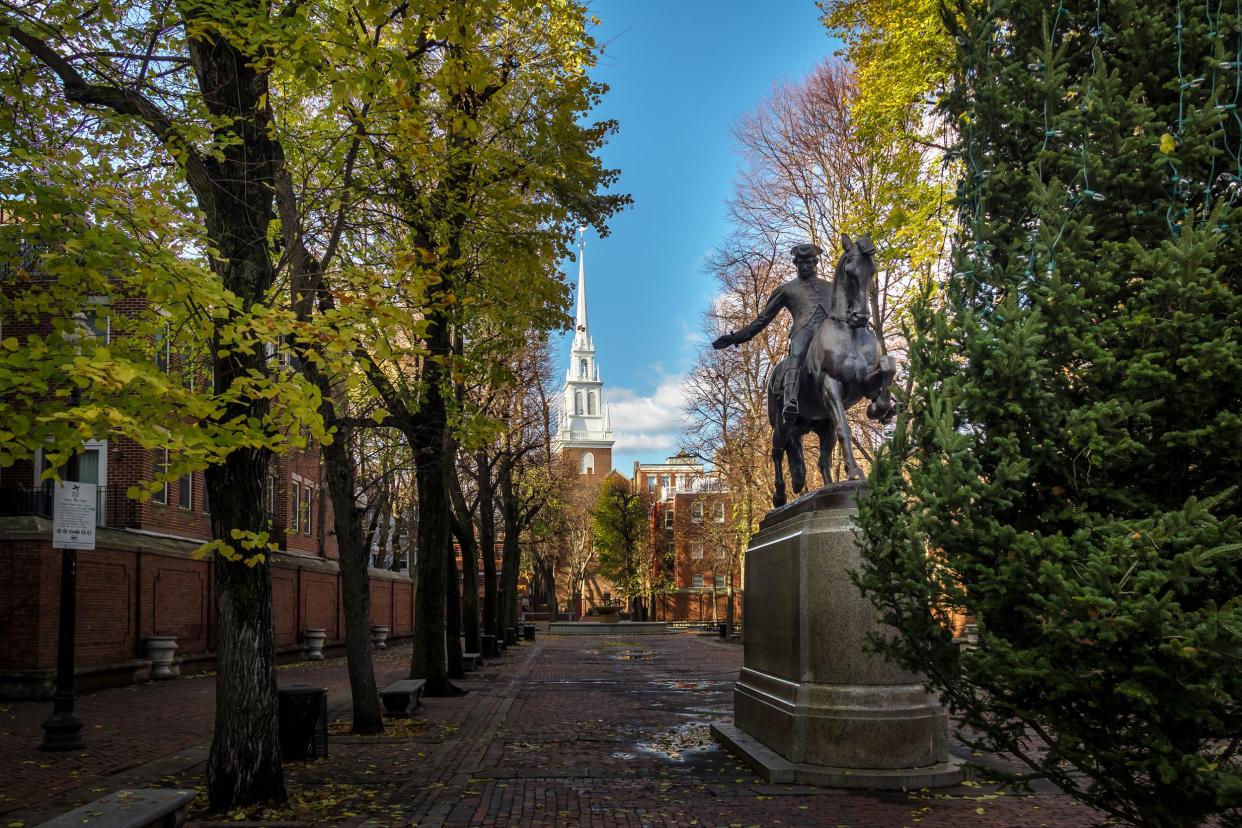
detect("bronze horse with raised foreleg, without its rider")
(768, 236), (897, 506)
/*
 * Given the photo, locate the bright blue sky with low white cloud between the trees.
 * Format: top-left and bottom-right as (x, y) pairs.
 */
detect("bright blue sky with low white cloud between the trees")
(560, 0), (840, 475)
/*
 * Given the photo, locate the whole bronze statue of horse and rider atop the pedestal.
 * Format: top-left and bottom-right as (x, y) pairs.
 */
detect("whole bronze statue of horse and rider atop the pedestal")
(712, 236), (897, 506)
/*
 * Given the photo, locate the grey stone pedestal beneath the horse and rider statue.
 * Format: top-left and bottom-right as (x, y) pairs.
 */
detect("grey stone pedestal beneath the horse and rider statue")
(717, 484), (963, 788)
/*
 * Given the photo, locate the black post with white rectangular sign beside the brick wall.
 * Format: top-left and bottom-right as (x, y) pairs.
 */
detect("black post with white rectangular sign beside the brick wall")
(39, 482), (98, 751)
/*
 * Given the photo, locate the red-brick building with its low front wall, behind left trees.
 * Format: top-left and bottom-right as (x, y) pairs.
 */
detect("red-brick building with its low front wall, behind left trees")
(0, 228), (414, 698)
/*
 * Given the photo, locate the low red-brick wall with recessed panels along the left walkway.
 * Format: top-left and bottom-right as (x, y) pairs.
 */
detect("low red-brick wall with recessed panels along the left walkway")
(0, 518), (414, 696)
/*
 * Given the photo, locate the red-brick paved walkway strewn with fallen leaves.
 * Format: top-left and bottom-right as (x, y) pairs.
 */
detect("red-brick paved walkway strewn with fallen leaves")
(0, 634), (1100, 828)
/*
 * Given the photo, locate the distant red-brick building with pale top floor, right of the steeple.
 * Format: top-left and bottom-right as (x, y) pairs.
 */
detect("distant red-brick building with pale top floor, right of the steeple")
(633, 452), (741, 622)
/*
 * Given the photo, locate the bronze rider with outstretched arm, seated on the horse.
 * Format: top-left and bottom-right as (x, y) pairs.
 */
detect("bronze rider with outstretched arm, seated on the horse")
(712, 239), (832, 422)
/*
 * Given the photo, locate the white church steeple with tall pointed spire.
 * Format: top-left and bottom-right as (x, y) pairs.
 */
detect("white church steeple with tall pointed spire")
(556, 227), (614, 474)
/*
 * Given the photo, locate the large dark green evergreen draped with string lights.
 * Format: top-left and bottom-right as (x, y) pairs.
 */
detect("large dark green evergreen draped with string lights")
(858, 0), (1242, 826)
